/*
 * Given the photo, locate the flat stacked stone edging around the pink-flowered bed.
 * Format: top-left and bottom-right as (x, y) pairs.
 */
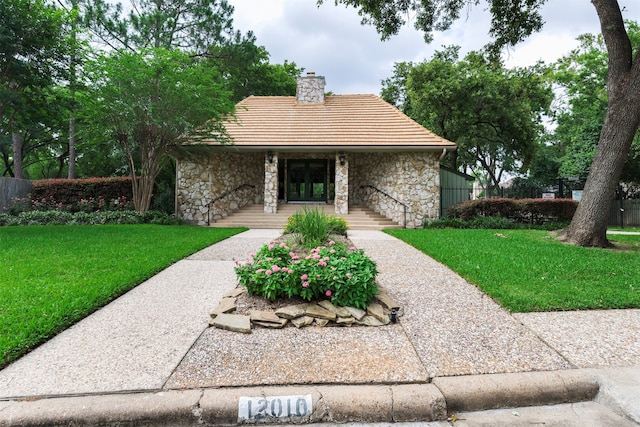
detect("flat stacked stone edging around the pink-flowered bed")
(209, 286), (401, 334)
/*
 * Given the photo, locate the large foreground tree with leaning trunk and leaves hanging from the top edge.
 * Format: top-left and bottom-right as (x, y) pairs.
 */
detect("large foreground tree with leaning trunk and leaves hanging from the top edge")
(328, 0), (640, 247)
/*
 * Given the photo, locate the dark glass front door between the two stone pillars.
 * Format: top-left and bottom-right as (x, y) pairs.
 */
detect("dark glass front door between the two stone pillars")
(287, 159), (327, 202)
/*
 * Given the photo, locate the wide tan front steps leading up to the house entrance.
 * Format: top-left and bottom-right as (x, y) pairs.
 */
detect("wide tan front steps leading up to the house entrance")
(211, 204), (402, 230)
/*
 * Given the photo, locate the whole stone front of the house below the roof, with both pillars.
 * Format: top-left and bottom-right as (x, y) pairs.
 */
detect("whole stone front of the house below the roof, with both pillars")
(176, 152), (440, 228)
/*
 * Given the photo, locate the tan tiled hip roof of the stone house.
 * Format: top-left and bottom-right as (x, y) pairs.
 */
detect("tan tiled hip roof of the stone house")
(200, 95), (456, 151)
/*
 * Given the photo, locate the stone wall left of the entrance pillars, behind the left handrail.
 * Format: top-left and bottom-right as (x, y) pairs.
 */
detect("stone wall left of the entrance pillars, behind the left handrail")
(176, 152), (265, 225)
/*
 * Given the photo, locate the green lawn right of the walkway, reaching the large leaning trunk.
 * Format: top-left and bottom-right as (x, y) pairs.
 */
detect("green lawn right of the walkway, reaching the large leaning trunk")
(387, 229), (640, 312)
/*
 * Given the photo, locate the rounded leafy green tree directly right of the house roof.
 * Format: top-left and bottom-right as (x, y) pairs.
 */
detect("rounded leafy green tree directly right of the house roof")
(382, 47), (553, 194)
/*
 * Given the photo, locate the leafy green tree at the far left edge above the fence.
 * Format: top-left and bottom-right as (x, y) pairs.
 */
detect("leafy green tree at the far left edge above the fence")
(0, 0), (68, 178)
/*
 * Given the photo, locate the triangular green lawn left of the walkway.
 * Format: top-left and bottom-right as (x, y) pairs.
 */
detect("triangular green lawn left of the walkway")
(0, 225), (243, 368)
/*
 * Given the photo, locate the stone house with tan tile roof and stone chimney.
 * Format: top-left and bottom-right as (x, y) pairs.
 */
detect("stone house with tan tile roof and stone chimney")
(176, 73), (456, 228)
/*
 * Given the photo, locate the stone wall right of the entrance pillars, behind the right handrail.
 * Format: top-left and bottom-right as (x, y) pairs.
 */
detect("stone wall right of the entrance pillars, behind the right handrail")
(350, 153), (440, 228)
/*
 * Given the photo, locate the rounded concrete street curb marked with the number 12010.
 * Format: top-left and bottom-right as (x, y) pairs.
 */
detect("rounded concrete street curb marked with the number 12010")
(0, 370), (599, 427)
